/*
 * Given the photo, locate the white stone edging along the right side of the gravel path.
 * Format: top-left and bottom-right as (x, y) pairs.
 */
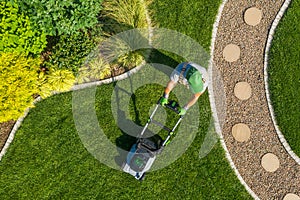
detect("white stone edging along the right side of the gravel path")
(264, 0), (300, 165)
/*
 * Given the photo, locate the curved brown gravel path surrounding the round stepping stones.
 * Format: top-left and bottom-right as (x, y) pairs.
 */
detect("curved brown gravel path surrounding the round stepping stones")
(213, 0), (300, 199)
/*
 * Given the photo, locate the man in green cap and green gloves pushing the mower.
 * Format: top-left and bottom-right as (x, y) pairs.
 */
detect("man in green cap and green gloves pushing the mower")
(160, 62), (208, 115)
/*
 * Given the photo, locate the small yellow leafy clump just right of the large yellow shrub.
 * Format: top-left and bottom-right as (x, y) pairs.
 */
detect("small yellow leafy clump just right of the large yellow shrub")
(39, 69), (75, 98)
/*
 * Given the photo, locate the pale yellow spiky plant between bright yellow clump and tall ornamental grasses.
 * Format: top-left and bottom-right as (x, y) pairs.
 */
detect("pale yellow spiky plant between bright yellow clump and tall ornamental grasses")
(77, 57), (111, 83)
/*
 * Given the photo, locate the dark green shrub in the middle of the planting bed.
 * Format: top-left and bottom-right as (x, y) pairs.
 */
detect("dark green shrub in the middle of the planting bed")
(43, 25), (101, 74)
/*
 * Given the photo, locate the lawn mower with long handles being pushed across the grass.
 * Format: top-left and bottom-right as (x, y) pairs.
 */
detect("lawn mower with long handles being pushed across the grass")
(122, 97), (183, 181)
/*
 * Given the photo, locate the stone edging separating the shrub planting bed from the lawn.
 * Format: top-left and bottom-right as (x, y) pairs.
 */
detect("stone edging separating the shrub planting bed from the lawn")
(0, 0), (153, 161)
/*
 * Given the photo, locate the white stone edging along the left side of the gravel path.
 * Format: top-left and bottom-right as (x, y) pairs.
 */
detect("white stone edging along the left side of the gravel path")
(208, 0), (259, 200)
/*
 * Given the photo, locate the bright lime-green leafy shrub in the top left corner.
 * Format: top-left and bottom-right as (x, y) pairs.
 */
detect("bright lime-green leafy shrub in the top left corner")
(0, 1), (47, 54)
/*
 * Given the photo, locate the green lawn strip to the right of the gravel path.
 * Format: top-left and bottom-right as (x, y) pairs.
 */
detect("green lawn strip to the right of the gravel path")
(268, 0), (300, 156)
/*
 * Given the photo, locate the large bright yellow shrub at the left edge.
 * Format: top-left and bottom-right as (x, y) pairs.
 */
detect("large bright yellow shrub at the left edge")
(0, 52), (40, 122)
